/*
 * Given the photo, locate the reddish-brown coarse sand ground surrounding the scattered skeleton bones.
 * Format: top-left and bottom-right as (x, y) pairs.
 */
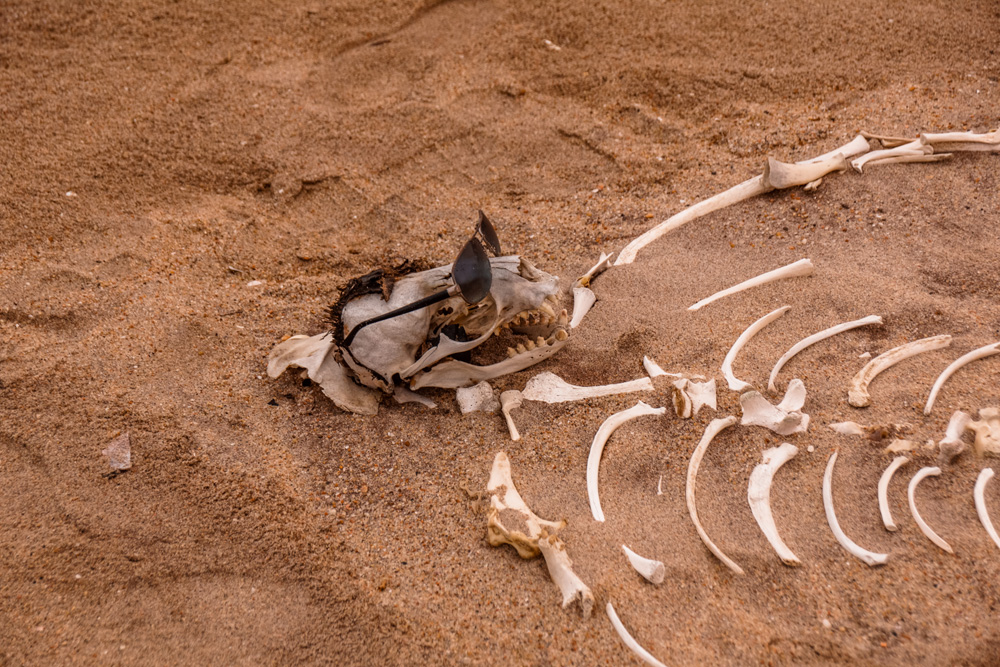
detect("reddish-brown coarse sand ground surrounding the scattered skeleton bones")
(0, 0), (1000, 665)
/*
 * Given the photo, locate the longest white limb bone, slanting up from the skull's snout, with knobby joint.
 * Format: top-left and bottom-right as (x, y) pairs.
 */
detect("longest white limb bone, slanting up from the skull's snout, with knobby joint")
(615, 135), (869, 266)
